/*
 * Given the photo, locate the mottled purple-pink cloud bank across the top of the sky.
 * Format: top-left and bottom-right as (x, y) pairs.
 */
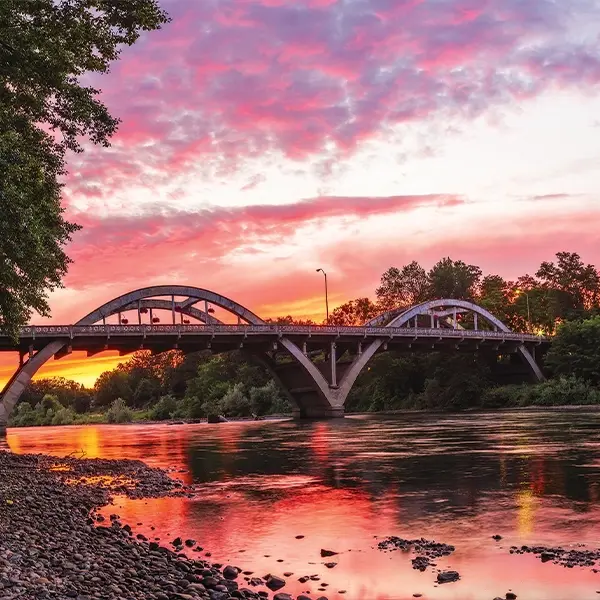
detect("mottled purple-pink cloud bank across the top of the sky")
(62, 0), (600, 202)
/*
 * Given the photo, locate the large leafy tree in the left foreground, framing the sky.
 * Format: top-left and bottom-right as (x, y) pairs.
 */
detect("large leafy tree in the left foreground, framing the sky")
(0, 0), (168, 337)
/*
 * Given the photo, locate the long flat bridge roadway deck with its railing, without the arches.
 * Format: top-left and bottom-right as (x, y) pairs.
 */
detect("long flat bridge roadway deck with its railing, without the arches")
(0, 324), (549, 356)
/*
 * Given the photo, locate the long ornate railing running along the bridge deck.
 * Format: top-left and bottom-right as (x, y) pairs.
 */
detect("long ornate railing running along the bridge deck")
(20, 324), (547, 342)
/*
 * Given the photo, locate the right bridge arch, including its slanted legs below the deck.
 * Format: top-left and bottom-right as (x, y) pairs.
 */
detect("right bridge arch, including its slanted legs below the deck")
(336, 298), (545, 406)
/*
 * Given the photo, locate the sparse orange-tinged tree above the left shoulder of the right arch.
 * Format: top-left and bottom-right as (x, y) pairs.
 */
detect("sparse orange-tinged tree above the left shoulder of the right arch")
(375, 260), (429, 312)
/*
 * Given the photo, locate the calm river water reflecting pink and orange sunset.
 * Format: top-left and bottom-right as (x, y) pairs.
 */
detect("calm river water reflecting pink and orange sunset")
(8, 412), (600, 600)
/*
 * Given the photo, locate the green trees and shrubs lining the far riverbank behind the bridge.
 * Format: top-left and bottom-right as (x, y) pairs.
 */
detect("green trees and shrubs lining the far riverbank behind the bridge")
(11, 252), (600, 425)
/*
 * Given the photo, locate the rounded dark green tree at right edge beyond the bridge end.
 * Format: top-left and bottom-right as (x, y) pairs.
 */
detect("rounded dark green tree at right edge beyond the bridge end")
(544, 316), (600, 385)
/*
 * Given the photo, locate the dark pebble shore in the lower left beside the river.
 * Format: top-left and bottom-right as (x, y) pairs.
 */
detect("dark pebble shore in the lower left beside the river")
(0, 451), (310, 600)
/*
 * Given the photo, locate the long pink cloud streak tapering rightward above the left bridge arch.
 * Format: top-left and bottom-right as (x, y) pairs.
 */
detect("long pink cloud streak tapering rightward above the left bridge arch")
(66, 194), (463, 289)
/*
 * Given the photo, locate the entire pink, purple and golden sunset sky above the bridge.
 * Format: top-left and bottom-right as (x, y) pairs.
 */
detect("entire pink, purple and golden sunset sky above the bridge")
(0, 0), (600, 384)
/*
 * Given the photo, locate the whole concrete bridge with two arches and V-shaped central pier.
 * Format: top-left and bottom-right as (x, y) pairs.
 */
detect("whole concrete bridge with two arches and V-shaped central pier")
(0, 286), (548, 427)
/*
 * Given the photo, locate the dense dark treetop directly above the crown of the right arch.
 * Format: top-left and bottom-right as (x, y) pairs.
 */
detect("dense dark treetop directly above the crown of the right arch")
(428, 257), (482, 300)
